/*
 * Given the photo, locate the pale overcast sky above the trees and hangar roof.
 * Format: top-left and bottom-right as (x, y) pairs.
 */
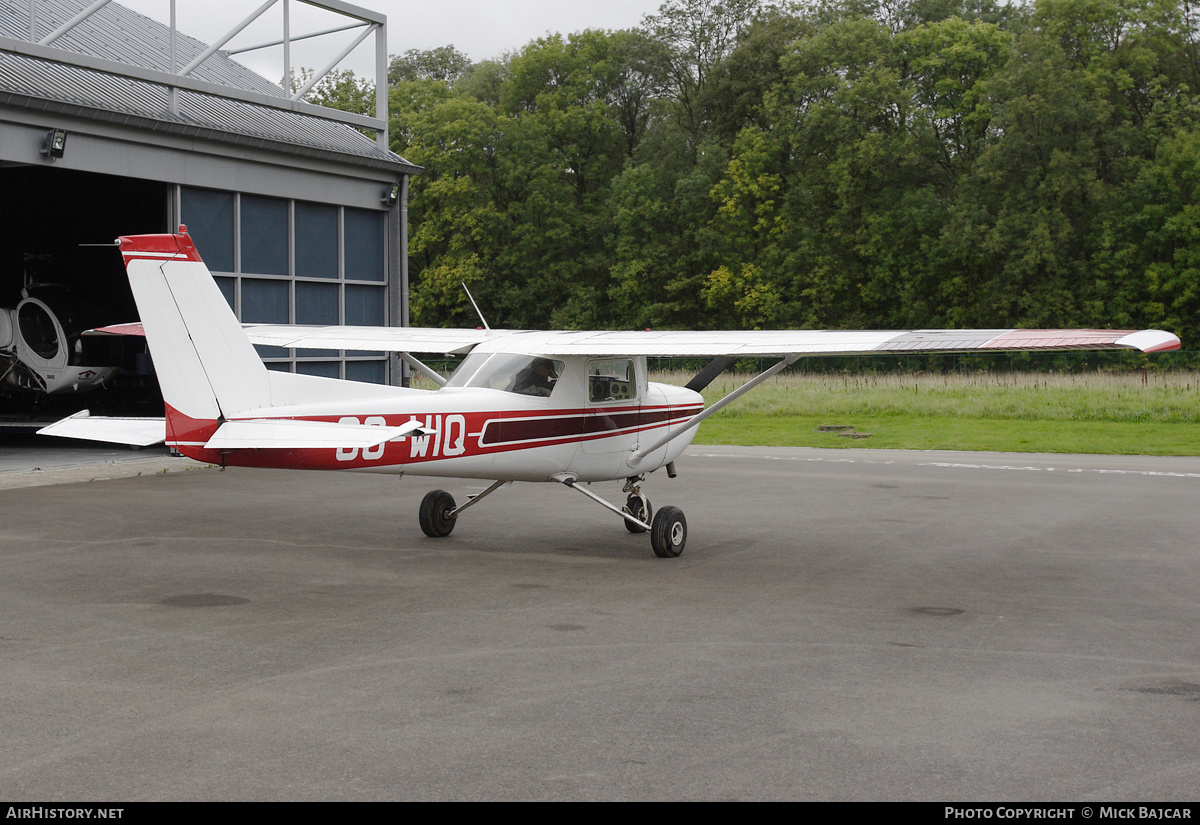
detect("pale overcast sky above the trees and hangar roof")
(116, 0), (662, 82)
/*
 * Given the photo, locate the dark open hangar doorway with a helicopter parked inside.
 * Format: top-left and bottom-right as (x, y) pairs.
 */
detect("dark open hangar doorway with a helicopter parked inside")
(0, 165), (169, 418)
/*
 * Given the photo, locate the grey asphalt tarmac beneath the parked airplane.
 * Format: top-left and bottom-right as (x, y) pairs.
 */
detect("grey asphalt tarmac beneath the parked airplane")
(0, 447), (1200, 801)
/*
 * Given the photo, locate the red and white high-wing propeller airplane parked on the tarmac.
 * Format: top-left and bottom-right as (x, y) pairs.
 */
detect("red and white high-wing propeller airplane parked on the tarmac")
(40, 225), (1180, 558)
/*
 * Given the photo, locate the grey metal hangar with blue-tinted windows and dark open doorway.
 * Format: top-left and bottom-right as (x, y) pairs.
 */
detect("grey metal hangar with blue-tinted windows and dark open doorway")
(0, 0), (420, 405)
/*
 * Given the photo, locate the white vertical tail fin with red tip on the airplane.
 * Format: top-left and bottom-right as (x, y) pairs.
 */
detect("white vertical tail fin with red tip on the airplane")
(118, 225), (271, 421)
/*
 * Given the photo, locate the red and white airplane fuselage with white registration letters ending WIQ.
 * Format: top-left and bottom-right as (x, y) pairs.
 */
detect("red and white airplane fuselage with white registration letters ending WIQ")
(167, 374), (703, 481)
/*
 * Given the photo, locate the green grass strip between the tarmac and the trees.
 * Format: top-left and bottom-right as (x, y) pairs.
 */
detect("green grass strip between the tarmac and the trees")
(652, 372), (1200, 456)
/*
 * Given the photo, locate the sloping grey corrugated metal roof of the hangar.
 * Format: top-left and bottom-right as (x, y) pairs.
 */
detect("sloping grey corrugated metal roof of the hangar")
(0, 0), (420, 174)
